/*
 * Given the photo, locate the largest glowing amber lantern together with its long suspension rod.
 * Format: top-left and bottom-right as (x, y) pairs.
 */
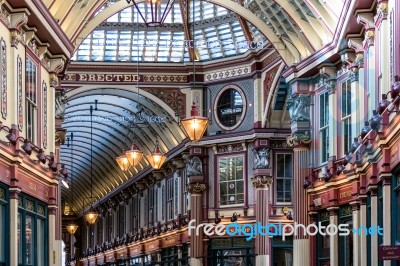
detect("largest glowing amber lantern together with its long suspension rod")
(181, 0), (209, 141)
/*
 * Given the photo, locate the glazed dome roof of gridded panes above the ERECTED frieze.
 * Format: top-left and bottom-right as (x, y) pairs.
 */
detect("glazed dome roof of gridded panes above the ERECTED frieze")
(72, 1), (267, 62)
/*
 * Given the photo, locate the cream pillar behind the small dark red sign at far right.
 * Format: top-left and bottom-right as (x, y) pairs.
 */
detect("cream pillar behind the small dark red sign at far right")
(382, 177), (392, 266)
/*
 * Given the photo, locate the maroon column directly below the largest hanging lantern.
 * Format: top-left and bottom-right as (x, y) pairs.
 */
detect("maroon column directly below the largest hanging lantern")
(187, 181), (206, 266)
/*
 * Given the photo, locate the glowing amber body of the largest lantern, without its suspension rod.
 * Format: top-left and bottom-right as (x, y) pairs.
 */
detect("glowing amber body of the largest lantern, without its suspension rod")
(181, 103), (209, 141)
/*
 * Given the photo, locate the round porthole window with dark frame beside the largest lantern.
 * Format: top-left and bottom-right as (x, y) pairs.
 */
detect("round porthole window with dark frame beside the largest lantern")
(215, 88), (246, 130)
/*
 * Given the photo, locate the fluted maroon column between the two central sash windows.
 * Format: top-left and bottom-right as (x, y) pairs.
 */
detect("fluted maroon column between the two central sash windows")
(252, 175), (273, 266)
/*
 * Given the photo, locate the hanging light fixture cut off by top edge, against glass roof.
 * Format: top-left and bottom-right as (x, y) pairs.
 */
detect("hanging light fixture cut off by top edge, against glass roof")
(126, 0), (175, 27)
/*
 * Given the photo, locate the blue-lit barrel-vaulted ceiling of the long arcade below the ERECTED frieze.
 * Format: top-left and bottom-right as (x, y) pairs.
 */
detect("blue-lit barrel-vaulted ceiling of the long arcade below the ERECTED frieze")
(61, 88), (185, 210)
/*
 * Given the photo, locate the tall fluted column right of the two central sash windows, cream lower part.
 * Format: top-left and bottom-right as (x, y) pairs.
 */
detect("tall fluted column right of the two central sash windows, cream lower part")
(292, 143), (311, 266)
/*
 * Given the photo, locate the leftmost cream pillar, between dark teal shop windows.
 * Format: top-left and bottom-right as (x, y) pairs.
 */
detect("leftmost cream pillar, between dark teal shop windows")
(10, 188), (21, 265)
